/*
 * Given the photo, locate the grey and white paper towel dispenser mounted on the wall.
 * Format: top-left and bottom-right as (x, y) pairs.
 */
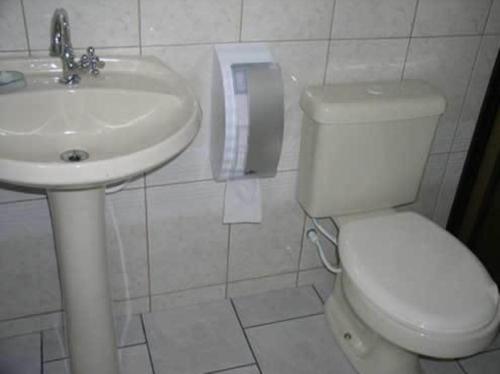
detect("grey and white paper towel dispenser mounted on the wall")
(211, 44), (284, 181)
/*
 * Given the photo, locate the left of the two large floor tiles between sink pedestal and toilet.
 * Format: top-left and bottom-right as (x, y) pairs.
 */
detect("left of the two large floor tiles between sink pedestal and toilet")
(144, 300), (253, 374)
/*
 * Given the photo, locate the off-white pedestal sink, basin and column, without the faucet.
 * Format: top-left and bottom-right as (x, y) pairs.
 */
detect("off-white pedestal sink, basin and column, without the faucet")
(0, 57), (201, 374)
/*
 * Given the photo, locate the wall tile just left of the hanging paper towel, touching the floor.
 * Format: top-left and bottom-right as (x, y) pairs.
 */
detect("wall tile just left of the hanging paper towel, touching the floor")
(147, 182), (228, 294)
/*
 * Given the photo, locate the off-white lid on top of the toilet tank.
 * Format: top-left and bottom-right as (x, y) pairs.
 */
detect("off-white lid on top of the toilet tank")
(300, 79), (446, 124)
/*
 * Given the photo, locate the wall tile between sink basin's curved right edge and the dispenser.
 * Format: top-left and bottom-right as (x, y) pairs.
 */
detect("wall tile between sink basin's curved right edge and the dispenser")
(142, 45), (213, 186)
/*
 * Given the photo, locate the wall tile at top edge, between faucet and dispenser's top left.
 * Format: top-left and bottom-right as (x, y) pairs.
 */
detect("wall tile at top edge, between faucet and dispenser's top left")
(141, 0), (241, 46)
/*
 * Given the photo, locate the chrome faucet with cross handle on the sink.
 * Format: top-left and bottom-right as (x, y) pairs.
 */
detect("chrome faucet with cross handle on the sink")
(50, 8), (104, 85)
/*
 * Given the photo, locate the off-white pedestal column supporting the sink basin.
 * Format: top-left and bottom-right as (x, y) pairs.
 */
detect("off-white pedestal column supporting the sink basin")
(47, 187), (118, 374)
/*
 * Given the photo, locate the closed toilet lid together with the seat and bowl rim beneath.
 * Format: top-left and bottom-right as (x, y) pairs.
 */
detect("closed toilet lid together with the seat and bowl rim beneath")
(339, 212), (499, 357)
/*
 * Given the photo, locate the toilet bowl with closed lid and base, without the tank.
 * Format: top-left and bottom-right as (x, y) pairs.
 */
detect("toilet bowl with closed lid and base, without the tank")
(325, 212), (500, 374)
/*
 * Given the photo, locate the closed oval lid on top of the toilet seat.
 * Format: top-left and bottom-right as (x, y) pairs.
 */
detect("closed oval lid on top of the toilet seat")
(339, 212), (498, 333)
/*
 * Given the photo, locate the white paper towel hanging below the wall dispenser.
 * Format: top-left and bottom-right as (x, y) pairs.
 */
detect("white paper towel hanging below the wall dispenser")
(224, 178), (262, 223)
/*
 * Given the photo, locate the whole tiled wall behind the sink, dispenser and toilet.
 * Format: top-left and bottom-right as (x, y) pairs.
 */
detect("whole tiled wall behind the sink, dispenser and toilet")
(0, 0), (500, 335)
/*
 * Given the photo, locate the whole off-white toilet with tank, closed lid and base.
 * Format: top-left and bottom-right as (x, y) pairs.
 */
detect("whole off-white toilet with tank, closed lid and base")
(298, 80), (500, 374)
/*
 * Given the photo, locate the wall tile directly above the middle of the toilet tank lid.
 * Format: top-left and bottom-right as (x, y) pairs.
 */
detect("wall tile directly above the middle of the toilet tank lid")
(326, 39), (409, 83)
